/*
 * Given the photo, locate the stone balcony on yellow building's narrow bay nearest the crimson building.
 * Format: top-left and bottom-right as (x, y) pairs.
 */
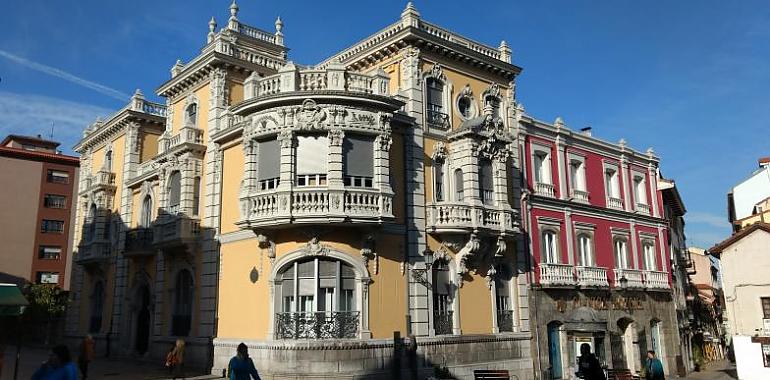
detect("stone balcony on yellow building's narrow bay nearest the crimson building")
(426, 202), (515, 233)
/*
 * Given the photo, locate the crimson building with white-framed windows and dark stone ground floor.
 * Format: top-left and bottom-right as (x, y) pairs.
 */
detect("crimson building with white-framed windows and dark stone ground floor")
(517, 122), (683, 379)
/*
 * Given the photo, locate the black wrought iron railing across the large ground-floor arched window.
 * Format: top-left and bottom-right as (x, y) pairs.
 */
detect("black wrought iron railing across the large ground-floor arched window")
(275, 311), (359, 339)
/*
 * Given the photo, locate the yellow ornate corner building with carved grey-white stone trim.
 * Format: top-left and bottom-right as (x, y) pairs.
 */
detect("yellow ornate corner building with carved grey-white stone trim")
(67, 3), (533, 379)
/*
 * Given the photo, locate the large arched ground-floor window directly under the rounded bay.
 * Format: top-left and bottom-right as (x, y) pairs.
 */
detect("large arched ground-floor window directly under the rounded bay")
(275, 257), (360, 339)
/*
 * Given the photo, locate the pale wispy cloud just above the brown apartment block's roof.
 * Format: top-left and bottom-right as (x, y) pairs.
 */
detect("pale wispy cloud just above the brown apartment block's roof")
(0, 91), (113, 152)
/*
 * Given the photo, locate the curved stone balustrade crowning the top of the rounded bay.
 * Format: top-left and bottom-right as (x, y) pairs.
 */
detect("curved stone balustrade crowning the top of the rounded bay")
(244, 63), (390, 100)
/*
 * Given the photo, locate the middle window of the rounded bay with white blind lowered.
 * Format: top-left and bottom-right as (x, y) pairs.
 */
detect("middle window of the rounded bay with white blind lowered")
(296, 135), (329, 186)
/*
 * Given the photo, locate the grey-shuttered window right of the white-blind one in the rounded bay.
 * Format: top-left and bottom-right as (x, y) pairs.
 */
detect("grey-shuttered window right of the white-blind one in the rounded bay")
(342, 135), (374, 187)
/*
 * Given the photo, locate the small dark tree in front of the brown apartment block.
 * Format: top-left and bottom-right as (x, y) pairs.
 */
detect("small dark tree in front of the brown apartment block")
(24, 284), (69, 344)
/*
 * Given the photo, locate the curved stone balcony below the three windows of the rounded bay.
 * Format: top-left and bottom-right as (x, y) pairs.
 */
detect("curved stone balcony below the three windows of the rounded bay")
(238, 187), (394, 228)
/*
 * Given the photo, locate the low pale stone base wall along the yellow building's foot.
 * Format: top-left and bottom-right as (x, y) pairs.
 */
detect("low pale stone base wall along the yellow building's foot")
(211, 333), (533, 380)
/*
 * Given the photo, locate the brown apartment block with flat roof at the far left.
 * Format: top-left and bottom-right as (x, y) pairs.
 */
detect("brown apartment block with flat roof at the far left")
(0, 135), (80, 289)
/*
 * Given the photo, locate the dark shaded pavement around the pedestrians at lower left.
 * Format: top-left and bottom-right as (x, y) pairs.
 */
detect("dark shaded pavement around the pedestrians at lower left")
(0, 347), (219, 380)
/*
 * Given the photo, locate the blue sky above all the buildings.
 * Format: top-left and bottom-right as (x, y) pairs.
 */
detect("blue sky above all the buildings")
(0, 0), (770, 247)
